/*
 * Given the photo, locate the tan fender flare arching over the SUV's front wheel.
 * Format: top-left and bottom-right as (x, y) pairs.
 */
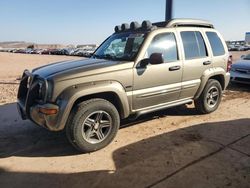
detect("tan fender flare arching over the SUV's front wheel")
(57, 81), (130, 130)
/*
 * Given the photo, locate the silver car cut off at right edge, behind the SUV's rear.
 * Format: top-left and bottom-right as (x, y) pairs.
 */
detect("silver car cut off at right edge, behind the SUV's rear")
(230, 54), (250, 84)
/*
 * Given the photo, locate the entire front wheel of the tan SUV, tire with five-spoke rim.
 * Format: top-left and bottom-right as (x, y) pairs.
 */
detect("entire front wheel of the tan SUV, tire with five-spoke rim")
(66, 99), (120, 152)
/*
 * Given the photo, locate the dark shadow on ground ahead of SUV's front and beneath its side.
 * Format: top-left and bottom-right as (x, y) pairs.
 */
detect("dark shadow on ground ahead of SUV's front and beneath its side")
(0, 103), (199, 158)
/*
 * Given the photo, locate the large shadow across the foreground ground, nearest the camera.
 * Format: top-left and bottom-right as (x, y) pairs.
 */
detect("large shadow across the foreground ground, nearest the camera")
(0, 119), (250, 188)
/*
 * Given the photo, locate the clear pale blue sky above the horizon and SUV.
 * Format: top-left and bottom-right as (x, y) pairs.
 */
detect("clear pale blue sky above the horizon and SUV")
(0, 0), (250, 44)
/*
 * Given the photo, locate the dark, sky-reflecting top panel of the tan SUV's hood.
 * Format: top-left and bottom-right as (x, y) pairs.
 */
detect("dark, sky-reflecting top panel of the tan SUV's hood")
(32, 59), (119, 78)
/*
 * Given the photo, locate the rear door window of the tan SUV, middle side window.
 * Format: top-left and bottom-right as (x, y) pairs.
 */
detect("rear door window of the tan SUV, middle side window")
(181, 31), (207, 60)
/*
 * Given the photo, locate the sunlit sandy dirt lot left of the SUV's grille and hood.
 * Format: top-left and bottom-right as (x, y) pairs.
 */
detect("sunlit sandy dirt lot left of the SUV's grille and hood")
(0, 52), (80, 105)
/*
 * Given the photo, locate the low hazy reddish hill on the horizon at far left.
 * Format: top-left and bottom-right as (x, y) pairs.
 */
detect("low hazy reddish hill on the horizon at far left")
(0, 41), (66, 49)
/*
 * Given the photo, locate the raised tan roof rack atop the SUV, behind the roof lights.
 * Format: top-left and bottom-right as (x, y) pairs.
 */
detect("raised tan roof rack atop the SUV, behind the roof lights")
(153, 19), (214, 28)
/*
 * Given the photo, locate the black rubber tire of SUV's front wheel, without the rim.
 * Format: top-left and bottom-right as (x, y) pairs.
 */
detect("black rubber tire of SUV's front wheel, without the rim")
(66, 98), (120, 153)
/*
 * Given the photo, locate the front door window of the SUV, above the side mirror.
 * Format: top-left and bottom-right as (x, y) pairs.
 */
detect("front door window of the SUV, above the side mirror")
(146, 33), (179, 62)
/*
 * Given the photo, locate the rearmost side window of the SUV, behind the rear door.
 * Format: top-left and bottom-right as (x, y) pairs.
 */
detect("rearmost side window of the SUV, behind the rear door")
(206, 32), (225, 56)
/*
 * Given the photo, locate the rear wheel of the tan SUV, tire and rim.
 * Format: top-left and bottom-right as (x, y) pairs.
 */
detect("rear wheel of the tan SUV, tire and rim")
(194, 79), (222, 114)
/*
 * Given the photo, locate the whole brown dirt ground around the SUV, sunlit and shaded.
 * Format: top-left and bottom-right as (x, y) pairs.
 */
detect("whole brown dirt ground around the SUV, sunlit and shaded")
(0, 52), (250, 188)
